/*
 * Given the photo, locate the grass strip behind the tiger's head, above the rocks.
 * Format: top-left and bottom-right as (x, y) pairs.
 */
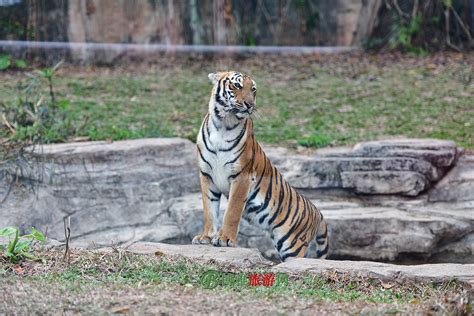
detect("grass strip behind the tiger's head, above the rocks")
(0, 53), (474, 149)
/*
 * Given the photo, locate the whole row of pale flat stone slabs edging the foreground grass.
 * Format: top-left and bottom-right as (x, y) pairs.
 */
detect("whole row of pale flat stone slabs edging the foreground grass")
(122, 242), (474, 284)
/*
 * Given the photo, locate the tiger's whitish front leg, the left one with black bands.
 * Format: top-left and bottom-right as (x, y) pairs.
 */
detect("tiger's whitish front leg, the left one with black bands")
(192, 173), (221, 244)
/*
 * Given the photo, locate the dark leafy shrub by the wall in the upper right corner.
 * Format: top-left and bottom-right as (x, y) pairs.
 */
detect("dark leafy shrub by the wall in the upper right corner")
(368, 0), (473, 55)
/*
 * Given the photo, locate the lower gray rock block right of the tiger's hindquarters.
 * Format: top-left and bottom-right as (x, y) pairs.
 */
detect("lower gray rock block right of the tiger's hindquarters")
(324, 202), (474, 263)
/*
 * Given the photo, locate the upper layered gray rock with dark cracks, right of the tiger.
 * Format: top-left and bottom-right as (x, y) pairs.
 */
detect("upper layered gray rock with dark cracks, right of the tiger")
(266, 139), (460, 196)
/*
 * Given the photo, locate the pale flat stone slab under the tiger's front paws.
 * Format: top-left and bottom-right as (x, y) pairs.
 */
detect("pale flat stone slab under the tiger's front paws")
(127, 242), (273, 268)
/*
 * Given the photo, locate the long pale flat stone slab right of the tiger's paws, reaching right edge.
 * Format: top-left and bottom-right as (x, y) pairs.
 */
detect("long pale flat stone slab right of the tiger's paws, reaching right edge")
(272, 258), (474, 284)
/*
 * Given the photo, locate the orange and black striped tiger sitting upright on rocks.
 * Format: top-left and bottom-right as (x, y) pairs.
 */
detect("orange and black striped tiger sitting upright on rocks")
(192, 71), (329, 261)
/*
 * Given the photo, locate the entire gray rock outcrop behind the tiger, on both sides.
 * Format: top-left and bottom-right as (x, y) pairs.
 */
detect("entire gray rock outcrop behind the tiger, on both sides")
(0, 138), (474, 263)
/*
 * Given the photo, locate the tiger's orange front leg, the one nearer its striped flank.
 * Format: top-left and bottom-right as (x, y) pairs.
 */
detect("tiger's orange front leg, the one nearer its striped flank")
(212, 175), (250, 247)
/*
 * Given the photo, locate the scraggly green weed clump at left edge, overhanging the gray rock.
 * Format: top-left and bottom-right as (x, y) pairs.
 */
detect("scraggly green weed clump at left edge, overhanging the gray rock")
(0, 62), (83, 204)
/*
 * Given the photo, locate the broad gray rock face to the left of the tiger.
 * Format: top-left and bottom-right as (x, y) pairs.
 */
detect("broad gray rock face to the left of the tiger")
(0, 138), (199, 245)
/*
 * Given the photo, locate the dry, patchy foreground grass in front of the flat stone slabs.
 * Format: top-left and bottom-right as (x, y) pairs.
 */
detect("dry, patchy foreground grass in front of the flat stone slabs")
(0, 250), (471, 314)
